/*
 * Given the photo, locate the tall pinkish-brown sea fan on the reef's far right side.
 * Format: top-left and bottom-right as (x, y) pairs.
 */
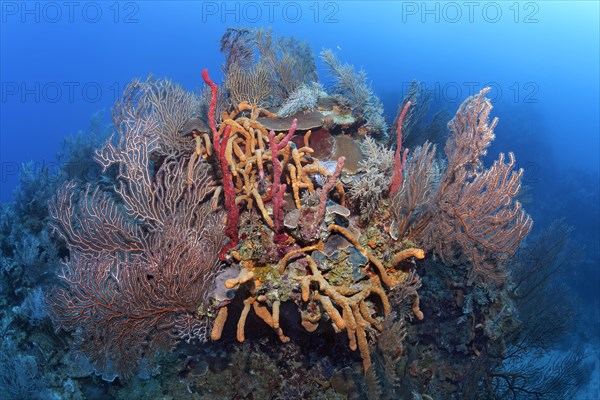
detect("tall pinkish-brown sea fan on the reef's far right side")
(423, 88), (532, 281)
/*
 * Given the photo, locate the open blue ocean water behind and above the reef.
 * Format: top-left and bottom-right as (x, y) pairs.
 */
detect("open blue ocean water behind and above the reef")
(0, 1), (600, 393)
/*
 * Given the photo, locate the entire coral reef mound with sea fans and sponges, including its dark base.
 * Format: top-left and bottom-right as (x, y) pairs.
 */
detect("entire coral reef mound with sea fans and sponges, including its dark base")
(7, 28), (584, 399)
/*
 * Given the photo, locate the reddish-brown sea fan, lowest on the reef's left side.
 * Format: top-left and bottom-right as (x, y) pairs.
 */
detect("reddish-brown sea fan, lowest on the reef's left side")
(48, 212), (224, 378)
